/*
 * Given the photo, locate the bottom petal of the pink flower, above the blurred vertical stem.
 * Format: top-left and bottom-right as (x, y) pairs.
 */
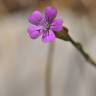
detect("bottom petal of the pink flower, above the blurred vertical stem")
(42, 30), (56, 43)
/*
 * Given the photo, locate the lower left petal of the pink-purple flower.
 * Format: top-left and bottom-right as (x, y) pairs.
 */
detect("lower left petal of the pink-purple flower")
(28, 25), (42, 39)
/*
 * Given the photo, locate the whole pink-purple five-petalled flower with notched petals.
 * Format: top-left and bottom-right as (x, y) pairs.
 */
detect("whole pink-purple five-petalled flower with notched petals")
(28, 7), (63, 43)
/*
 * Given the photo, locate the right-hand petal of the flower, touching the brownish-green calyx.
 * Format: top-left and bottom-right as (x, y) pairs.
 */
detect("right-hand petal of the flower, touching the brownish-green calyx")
(50, 19), (63, 32)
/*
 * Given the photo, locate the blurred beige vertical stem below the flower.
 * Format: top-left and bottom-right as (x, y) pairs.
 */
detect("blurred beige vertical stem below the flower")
(45, 43), (55, 96)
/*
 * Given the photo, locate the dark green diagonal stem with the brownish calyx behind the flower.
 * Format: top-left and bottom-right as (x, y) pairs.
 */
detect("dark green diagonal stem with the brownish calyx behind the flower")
(55, 27), (96, 66)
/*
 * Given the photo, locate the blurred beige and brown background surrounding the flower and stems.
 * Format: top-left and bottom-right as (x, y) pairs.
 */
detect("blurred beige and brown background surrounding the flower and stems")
(0, 0), (96, 96)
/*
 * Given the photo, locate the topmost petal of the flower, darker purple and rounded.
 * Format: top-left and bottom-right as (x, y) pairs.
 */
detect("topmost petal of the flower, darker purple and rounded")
(45, 6), (57, 22)
